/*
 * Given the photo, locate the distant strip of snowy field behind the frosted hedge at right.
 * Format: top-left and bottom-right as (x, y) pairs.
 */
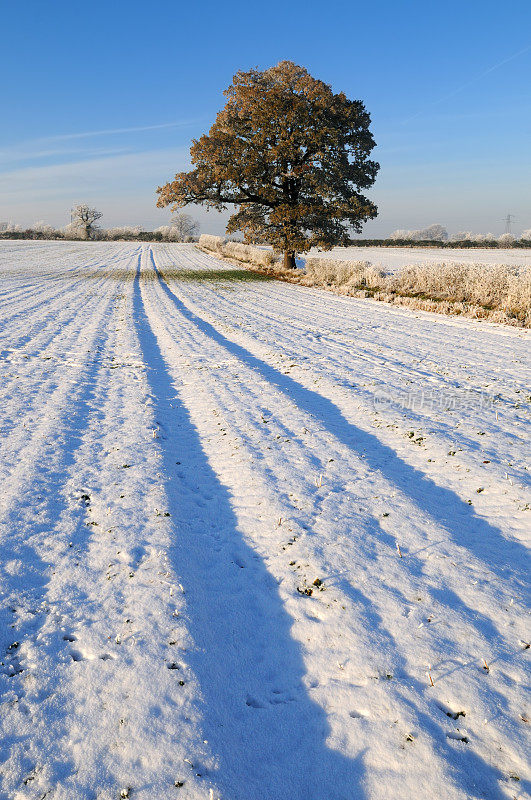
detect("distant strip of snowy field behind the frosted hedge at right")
(309, 247), (531, 272)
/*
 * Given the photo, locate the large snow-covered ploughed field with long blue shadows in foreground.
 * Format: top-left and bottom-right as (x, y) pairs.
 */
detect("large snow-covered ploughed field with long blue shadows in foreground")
(0, 242), (530, 800)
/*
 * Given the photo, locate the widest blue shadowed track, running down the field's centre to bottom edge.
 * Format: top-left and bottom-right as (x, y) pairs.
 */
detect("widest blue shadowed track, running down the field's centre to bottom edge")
(133, 261), (365, 800)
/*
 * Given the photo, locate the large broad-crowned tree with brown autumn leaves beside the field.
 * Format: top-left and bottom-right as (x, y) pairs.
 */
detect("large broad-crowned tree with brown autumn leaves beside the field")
(157, 61), (379, 267)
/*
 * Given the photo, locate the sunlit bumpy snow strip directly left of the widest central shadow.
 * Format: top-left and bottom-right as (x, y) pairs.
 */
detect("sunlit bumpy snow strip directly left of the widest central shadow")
(0, 247), (216, 800)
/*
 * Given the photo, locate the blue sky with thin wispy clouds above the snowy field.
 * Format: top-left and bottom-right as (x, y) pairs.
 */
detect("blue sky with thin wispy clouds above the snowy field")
(0, 0), (531, 236)
